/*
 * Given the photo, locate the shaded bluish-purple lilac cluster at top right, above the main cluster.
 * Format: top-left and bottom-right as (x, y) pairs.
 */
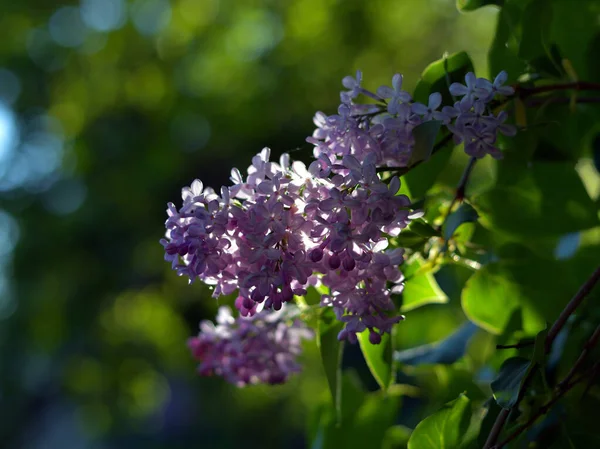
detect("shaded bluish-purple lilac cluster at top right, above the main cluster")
(307, 71), (515, 163)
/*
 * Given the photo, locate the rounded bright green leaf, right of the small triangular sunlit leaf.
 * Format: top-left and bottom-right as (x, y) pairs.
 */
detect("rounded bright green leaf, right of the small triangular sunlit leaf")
(461, 263), (521, 334)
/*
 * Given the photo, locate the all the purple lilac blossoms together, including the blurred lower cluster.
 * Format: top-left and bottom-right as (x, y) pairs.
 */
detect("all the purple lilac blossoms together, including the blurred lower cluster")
(161, 72), (514, 385)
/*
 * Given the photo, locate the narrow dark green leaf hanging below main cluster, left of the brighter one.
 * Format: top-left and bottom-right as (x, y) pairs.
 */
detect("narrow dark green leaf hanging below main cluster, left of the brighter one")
(317, 309), (344, 420)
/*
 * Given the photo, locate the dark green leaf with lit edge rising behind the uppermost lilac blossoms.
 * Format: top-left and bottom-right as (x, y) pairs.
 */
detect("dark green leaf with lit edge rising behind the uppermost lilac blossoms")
(413, 52), (475, 105)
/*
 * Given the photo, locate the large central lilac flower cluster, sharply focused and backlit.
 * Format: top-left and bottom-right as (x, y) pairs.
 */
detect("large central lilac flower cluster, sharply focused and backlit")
(161, 144), (413, 342)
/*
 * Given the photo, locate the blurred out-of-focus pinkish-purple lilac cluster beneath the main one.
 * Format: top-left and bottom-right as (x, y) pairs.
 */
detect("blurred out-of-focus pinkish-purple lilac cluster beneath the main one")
(188, 307), (312, 387)
